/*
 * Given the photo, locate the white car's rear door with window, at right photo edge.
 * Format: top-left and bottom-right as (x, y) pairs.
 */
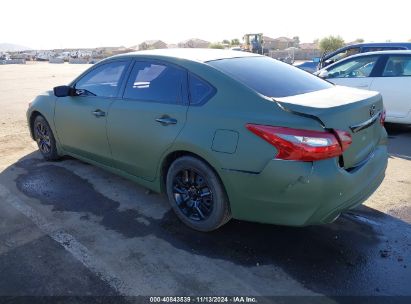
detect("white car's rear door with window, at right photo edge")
(370, 55), (411, 119)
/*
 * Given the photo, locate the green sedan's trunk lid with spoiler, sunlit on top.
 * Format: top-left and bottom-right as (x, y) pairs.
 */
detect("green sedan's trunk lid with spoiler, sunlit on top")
(274, 86), (383, 169)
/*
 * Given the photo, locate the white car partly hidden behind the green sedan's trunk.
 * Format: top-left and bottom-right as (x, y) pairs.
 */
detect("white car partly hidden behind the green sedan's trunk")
(315, 51), (411, 124)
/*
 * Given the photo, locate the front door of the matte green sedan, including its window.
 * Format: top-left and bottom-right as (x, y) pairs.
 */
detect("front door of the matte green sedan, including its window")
(54, 61), (128, 163)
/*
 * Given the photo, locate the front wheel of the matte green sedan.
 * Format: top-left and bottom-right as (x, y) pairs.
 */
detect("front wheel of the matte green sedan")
(32, 115), (60, 161)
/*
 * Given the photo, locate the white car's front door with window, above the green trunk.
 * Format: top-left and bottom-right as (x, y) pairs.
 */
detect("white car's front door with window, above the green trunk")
(327, 55), (381, 90)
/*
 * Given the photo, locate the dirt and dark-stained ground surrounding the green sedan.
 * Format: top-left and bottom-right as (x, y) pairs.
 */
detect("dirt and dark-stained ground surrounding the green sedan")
(0, 64), (411, 302)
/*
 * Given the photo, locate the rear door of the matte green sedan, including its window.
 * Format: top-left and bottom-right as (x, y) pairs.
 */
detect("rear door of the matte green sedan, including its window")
(107, 60), (188, 180)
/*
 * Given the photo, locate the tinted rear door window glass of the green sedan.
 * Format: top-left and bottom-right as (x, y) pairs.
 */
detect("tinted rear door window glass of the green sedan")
(123, 61), (186, 104)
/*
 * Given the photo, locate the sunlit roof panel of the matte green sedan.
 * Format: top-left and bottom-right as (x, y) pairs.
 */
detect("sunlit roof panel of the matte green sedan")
(109, 48), (261, 62)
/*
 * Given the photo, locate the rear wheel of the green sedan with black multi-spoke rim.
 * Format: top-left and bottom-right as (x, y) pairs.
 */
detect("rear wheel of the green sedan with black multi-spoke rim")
(166, 156), (231, 232)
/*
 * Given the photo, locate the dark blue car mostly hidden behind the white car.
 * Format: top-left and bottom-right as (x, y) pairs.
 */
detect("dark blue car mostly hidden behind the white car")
(297, 42), (411, 73)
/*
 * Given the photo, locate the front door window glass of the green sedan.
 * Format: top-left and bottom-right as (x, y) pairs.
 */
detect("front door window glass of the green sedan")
(75, 61), (127, 97)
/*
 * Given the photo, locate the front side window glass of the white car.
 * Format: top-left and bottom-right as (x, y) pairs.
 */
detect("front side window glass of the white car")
(327, 56), (378, 78)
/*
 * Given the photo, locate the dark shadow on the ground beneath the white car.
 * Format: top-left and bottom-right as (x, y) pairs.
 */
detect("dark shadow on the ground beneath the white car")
(385, 123), (411, 160)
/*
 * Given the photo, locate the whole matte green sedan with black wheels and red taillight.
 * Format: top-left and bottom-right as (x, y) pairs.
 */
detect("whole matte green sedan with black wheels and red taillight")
(27, 49), (387, 231)
